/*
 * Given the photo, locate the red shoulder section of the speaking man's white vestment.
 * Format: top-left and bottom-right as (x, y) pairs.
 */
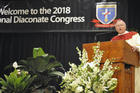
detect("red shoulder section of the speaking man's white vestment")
(111, 31), (137, 41)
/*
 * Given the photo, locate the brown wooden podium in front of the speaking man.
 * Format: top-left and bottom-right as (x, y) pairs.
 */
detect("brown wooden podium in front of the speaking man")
(83, 40), (139, 93)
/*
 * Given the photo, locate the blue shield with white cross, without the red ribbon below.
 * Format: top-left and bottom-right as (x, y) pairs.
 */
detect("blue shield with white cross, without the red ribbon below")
(96, 2), (117, 24)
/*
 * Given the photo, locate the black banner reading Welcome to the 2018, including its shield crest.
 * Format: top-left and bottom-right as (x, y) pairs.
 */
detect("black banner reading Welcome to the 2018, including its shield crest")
(0, 0), (128, 32)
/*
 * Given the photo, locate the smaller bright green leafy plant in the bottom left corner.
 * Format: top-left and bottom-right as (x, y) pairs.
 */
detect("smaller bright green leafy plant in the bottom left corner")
(0, 69), (36, 93)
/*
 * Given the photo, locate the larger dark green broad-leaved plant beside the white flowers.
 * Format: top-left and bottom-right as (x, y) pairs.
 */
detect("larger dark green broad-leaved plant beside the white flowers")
(18, 48), (64, 90)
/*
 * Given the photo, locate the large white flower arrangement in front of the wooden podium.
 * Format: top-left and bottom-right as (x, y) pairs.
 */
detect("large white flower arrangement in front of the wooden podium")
(59, 43), (117, 93)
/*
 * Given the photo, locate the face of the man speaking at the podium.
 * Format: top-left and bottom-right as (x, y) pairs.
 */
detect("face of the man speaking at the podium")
(115, 21), (126, 34)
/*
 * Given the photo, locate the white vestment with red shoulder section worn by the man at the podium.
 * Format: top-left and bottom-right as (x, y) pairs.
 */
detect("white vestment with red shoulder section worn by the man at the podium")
(111, 31), (140, 93)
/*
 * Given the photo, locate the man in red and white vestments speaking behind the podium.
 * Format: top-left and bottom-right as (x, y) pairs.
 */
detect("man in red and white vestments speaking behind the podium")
(111, 20), (140, 93)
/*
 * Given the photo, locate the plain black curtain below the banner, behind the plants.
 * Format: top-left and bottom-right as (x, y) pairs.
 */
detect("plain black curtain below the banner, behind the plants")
(0, 32), (114, 74)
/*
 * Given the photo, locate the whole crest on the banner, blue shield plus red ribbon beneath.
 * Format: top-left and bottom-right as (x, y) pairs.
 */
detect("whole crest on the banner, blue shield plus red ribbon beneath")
(92, 2), (117, 27)
